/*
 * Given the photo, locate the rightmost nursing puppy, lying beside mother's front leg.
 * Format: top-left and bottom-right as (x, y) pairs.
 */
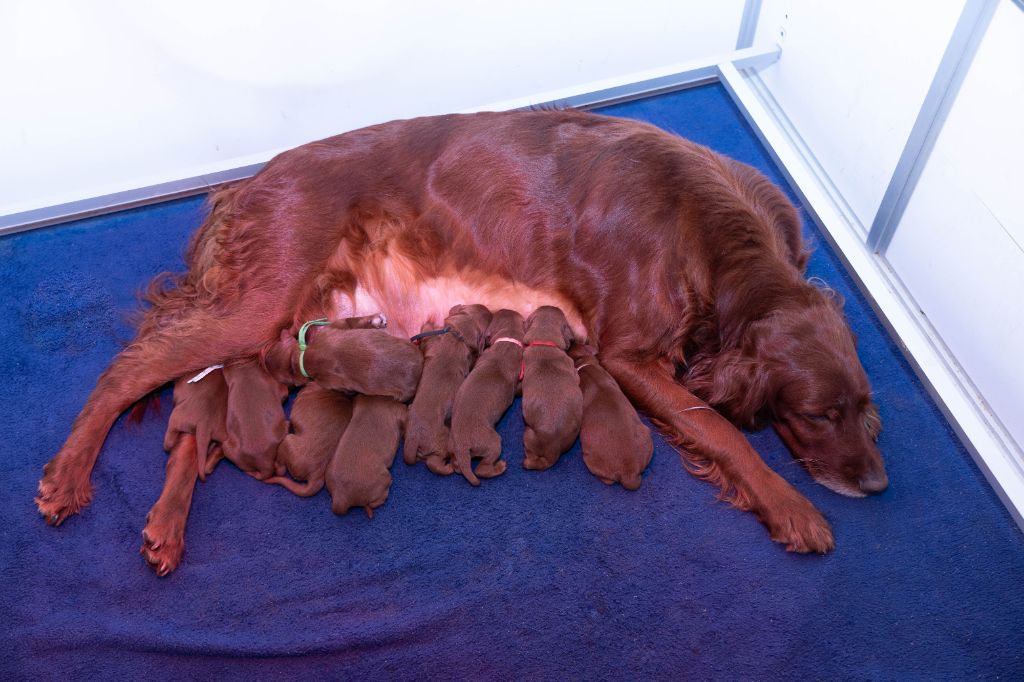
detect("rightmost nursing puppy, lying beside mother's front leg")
(569, 344), (654, 491)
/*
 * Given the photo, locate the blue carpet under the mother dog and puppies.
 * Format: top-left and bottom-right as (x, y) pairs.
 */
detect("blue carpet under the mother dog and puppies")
(0, 85), (1024, 681)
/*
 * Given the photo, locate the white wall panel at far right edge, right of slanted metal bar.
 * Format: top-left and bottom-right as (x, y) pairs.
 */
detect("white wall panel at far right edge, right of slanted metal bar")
(886, 0), (1024, 443)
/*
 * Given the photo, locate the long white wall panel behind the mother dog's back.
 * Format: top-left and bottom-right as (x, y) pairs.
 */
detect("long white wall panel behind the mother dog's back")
(0, 0), (743, 215)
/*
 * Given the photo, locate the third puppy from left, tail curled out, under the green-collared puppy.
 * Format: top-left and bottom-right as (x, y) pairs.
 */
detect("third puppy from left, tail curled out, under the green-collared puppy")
(266, 382), (352, 498)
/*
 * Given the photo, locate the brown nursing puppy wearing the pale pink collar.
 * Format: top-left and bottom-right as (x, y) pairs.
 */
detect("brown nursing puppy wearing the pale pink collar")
(449, 310), (524, 485)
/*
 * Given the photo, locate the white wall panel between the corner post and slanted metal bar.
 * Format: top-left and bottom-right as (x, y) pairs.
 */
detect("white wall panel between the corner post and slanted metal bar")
(755, 0), (964, 226)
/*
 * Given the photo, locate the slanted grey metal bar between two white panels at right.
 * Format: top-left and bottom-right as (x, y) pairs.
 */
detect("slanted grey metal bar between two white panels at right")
(867, 0), (999, 254)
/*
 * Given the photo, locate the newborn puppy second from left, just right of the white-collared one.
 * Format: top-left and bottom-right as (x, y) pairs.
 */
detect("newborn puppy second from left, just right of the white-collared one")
(215, 359), (288, 480)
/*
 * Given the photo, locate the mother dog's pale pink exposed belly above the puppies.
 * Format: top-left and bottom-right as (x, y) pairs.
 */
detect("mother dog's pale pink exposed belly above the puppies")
(328, 272), (587, 340)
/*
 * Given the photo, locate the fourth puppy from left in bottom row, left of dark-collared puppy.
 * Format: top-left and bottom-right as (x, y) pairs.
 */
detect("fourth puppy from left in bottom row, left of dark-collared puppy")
(325, 395), (408, 518)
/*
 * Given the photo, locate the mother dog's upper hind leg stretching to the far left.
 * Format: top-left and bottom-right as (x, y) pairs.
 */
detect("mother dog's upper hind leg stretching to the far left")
(36, 294), (293, 525)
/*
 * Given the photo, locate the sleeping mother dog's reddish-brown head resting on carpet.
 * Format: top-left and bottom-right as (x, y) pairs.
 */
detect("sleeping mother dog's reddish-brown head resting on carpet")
(685, 283), (889, 497)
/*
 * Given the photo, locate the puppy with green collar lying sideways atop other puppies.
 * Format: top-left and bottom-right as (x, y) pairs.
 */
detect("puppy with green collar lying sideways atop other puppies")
(263, 315), (423, 402)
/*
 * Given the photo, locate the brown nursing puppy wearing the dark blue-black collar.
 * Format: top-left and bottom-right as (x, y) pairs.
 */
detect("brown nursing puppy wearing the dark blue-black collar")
(402, 305), (490, 475)
